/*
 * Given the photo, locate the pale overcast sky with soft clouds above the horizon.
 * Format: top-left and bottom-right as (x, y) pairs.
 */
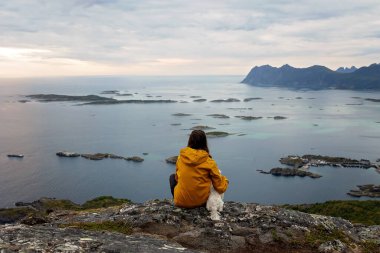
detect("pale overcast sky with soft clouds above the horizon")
(0, 0), (380, 77)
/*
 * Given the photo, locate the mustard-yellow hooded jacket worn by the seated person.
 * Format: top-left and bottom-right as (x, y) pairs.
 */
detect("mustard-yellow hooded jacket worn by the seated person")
(174, 147), (228, 208)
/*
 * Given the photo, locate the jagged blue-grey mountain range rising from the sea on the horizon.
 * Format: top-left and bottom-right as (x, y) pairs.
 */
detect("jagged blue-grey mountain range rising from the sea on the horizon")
(242, 64), (380, 90)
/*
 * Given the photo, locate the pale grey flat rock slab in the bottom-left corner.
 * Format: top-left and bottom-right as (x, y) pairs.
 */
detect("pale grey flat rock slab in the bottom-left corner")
(0, 225), (194, 253)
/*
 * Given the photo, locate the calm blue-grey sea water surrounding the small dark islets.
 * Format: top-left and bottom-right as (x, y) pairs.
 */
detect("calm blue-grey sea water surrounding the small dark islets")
(0, 76), (380, 207)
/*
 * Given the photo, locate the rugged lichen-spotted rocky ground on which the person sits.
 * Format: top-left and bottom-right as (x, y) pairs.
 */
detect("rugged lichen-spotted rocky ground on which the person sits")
(0, 199), (380, 253)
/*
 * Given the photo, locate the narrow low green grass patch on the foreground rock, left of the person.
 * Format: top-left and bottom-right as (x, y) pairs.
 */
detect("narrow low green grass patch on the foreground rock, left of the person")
(60, 221), (132, 235)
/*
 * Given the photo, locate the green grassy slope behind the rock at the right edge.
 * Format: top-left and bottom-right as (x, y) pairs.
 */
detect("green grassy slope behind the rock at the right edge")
(282, 200), (380, 225)
